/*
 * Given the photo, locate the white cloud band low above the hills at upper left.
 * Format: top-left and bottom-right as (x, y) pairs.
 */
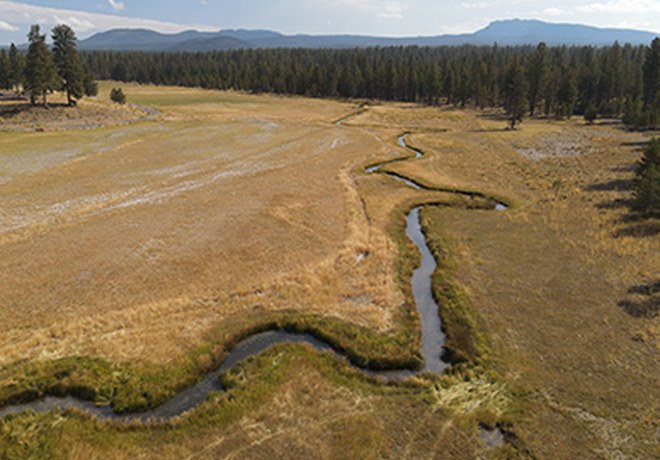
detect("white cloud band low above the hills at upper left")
(0, 0), (218, 37)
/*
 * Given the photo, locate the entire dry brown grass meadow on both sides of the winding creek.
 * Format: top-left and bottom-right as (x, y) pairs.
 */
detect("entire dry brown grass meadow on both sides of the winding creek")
(0, 83), (660, 459)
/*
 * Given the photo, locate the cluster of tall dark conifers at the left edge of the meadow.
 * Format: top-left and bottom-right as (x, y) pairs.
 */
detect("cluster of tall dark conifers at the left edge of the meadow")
(0, 24), (98, 106)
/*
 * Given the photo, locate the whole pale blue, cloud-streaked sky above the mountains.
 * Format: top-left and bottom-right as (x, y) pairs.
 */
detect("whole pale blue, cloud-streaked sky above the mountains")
(0, 0), (660, 44)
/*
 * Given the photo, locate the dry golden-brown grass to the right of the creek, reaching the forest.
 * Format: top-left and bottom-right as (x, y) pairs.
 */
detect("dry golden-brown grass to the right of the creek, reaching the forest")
(372, 109), (660, 458)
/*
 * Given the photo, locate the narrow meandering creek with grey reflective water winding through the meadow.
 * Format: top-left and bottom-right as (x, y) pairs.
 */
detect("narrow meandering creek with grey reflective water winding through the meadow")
(0, 127), (507, 421)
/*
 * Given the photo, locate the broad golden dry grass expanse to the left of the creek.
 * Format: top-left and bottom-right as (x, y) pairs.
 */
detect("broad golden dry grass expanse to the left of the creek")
(0, 82), (412, 364)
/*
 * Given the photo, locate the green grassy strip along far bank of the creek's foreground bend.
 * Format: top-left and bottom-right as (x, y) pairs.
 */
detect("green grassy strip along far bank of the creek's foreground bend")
(0, 313), (421, 413)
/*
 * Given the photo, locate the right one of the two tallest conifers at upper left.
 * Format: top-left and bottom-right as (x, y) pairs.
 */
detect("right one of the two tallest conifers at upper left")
(52, 24), (85, 106)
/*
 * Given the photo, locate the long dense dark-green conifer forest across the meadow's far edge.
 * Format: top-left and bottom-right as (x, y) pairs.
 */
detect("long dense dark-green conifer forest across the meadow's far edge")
(84, 39), (660, 128)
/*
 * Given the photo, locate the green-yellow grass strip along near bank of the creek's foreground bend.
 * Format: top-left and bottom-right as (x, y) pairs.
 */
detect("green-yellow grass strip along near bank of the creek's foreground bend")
(0, 344), (428, 459)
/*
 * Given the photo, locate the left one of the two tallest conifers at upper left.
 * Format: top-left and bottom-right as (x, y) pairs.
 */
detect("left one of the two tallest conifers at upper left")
(25, 25), (59, 107)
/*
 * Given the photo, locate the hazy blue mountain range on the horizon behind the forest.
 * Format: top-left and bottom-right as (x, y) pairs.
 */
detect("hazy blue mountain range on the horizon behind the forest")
(79, 19), (658, 51)
